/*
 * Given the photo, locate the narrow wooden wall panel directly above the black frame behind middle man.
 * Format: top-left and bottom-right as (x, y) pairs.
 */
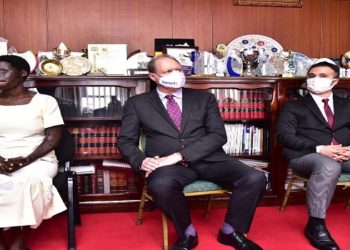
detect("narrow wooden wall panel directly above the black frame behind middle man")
(173, 0), (213, 51)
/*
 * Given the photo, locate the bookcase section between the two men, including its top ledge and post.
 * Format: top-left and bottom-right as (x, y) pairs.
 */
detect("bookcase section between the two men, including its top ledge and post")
(185, 77), (281, 200)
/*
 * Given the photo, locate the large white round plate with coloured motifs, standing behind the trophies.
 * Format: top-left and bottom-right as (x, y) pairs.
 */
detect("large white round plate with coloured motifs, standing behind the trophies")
(227, 35), (283, 57)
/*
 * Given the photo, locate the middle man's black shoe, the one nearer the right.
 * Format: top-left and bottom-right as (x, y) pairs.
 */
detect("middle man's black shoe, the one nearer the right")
(218, 230), (262, 250)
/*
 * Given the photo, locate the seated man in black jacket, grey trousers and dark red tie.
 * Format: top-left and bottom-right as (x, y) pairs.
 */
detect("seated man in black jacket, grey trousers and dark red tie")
(277, 59), (350, 249)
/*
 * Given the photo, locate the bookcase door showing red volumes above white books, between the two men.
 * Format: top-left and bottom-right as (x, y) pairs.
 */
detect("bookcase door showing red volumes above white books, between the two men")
(208, 87), (274, 193)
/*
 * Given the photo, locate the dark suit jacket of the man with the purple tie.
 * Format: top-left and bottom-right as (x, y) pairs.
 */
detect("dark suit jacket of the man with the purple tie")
(117, 89), (230, 170)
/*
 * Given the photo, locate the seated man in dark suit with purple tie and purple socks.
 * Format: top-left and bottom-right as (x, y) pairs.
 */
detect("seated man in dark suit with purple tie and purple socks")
(118, 55), (266, 250)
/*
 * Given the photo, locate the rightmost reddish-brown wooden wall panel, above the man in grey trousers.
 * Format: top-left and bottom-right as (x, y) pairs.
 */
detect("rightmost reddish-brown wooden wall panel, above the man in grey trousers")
(322, 0), (350, 58)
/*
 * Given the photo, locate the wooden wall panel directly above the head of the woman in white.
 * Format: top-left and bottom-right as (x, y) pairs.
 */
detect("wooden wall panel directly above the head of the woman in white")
(3, 0), (47, 52)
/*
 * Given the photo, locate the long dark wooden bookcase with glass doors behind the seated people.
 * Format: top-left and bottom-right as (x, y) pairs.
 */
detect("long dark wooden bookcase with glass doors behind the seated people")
(25, 76), (350, 212)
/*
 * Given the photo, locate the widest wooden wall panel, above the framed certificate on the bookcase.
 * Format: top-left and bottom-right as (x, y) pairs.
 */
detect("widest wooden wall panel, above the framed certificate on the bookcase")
(48, 0), (172, 53)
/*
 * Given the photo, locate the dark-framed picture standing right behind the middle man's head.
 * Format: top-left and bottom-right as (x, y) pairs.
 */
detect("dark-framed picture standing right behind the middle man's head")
(163, 46), (198, 75)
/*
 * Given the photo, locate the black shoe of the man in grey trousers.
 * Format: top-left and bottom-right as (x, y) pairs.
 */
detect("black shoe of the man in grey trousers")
(304, 223), (340, 250)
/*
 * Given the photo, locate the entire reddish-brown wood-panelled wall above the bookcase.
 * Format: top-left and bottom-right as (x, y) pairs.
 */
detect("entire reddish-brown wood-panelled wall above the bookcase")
(0, 0), (350, 57)
